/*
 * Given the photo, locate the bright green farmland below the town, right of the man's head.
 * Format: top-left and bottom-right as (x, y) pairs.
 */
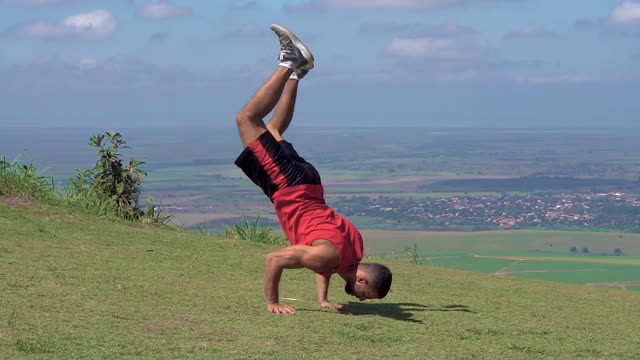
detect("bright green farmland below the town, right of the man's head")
(363, 230), (640, 291)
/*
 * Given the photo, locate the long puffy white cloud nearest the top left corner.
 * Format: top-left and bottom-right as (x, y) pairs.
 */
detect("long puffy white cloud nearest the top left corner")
(15, 10), (118, 40)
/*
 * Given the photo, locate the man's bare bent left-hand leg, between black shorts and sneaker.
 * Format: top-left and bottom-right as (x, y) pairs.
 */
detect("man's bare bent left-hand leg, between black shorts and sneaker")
(236, 66), (297, 147)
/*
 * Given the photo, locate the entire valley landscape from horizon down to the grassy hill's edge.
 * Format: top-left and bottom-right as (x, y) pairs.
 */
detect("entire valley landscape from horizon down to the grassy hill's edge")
(0, 128), (640, 290)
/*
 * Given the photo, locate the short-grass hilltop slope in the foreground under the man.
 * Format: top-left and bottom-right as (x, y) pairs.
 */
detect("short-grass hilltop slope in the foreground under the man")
(0, 196), (640, 359)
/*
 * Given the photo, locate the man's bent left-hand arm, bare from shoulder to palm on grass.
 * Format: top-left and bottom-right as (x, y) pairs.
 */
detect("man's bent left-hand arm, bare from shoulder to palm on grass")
(264, 241), (339, 314)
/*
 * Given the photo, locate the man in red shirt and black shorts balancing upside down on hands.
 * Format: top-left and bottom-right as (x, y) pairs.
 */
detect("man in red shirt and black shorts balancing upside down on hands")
(235, 25), (392, 314)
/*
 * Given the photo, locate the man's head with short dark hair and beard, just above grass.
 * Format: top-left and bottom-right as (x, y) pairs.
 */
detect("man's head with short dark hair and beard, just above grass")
(344, 263), (392, 301)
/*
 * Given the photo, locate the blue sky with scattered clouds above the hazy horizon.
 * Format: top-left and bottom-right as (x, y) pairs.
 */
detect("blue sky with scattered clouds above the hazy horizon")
(0, 0), (640, 128)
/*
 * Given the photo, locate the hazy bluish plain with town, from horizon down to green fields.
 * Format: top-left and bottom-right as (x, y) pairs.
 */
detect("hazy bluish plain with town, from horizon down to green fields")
(0, 128), (640, 232)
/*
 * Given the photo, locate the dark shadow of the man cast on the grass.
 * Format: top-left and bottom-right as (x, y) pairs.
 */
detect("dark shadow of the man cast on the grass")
(340, 302), (475, 324)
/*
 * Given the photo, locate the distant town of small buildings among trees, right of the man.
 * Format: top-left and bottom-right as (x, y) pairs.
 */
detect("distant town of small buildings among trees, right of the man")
(331, 192), (640, 232)
